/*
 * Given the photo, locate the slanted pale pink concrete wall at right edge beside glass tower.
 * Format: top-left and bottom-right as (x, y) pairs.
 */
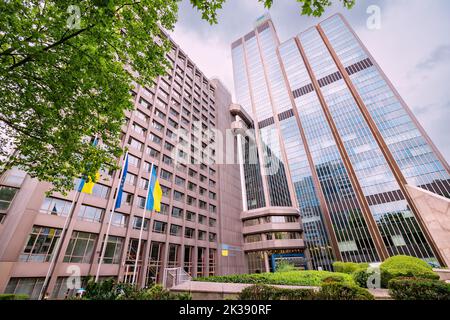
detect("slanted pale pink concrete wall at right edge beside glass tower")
(406, 185), (450, 267)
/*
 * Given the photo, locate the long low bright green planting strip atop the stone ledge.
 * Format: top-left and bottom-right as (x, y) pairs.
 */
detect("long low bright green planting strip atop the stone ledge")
(193, 270), (355, 286)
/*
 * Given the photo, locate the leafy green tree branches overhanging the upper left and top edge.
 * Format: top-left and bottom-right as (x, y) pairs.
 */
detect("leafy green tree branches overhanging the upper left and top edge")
(0, 0), (353, 192)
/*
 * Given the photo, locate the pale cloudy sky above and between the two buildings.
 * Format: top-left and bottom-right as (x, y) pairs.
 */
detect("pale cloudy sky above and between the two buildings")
(171, 0), (450, 161)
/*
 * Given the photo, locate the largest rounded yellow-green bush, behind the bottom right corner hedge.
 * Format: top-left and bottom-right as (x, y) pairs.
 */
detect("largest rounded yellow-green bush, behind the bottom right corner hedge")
(380, 256), (439, 288)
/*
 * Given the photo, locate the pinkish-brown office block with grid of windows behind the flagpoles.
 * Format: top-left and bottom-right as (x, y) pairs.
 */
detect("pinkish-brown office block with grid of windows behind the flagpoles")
(0, 31), (246, 298)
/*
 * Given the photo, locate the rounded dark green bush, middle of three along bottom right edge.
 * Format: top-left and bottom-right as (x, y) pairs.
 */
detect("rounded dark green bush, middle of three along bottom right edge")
(317, 282), (375, 300)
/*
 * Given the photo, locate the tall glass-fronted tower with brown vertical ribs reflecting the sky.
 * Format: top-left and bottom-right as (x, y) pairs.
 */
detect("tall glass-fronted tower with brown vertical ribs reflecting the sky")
(231, 15), (450, 271)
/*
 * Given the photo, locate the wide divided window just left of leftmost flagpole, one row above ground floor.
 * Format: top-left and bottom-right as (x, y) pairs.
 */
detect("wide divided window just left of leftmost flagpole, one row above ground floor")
(19, 226), (61, 262)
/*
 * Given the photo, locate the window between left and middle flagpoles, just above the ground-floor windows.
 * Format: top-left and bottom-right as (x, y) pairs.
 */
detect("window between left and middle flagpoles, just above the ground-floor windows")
(64, 231), (97, 263)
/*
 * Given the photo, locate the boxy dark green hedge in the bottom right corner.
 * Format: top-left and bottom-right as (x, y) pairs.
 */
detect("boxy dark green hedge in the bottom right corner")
(388, 278), (450, 300)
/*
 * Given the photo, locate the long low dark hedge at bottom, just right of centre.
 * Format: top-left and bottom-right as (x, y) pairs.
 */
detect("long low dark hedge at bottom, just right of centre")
(238, 284), (316, 300)
